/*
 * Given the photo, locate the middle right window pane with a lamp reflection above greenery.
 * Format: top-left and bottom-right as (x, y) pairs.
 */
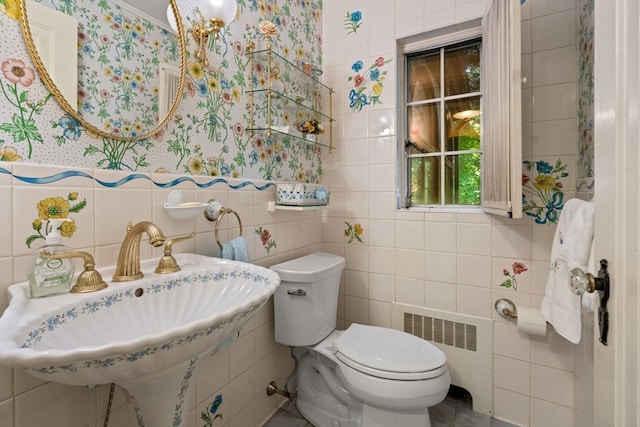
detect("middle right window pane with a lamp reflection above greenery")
(445, 96), (480, 151)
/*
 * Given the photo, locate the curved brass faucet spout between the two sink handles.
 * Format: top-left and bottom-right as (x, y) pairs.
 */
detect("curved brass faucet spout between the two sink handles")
(113, 221), (165, 282)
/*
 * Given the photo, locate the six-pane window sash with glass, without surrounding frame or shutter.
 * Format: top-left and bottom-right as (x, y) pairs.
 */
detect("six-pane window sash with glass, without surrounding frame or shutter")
(404, 38), (482, 207)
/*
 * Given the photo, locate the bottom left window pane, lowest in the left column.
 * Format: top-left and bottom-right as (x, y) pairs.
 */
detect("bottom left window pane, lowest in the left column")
(410, 157), (441, 205)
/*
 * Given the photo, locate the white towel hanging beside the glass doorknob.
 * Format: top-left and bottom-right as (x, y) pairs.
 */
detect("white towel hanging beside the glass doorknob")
(540, 199), (594, 344)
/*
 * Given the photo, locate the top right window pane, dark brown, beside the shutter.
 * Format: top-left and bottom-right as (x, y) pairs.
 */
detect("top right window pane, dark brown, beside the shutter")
(444, 42), (480, 96)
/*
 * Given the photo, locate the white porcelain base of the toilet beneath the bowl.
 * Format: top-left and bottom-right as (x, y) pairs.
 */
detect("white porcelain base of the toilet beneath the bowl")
(296, 349), (431, 427)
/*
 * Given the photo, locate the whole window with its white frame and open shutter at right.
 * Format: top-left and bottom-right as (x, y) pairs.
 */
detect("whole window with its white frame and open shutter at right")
(397, 0), (522, 214)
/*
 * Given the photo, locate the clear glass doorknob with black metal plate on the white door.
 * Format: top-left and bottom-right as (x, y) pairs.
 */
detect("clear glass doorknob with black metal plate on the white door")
(569, 259), (610, 345)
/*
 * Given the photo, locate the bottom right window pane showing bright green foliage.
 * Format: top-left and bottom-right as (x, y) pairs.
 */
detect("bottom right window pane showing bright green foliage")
(445, 153), (480, 205)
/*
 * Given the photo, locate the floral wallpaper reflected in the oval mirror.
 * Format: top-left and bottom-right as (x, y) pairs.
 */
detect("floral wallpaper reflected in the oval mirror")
(37, 0), (180, 138)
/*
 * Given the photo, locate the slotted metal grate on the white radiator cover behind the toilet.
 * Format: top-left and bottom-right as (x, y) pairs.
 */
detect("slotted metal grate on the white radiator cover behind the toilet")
(404, 313), (478, 351)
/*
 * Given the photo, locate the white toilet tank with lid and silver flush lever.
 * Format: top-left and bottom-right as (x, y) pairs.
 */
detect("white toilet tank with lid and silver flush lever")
(271, 252), (345, 347)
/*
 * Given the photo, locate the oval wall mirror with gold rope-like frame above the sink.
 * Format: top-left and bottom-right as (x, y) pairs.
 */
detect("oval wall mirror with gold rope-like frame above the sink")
(22, 0), (185, 140)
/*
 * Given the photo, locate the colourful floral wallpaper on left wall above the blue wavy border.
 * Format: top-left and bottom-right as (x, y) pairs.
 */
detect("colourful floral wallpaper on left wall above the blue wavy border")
(0, 0), (328, 182)
